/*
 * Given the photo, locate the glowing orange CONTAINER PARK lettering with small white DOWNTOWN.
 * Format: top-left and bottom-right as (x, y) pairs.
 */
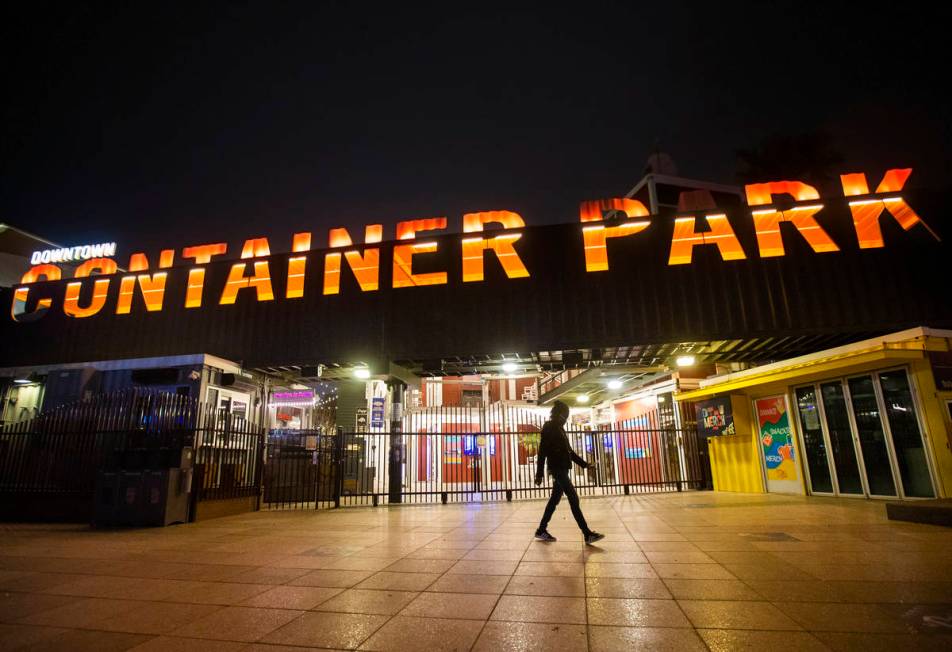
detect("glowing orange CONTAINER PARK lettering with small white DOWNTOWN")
(11, 169), (939, 322)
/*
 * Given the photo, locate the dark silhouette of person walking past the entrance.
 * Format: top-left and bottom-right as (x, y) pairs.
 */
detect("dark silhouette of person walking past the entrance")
(535, 401), (605, 545)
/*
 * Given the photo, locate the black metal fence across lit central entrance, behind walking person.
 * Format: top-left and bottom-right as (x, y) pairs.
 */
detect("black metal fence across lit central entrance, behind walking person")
(340, 428), (702, 505)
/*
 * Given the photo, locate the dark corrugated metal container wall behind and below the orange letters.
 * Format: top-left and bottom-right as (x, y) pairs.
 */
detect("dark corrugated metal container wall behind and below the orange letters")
(0, 191), (952, 366)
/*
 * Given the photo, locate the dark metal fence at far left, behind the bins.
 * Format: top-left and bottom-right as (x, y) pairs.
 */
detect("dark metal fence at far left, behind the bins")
(0, 391), (264, 520)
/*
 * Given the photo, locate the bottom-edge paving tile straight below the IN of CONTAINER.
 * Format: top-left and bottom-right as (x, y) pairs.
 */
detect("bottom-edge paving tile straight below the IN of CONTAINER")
(261, 611), (389, 650)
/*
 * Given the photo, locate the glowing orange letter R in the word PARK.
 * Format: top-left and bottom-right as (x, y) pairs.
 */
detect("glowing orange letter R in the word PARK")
(745, 181), (840, 258)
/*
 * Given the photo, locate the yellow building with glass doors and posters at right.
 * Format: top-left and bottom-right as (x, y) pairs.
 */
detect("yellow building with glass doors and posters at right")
(676, 328), (952, 499)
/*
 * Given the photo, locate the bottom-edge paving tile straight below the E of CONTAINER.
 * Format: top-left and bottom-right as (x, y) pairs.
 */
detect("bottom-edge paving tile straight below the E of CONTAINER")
(360, 616), (483, 652)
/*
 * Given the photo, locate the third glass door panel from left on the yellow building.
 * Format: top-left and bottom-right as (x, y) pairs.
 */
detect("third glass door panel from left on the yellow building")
(846, 376), (897, 496)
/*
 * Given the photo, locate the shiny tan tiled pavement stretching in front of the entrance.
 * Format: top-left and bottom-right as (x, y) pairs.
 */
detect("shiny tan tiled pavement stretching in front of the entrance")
(0, 493), (952, 652)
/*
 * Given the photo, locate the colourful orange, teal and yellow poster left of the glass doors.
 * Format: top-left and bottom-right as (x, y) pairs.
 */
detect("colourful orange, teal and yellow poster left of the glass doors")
(754, 395), (801, 493)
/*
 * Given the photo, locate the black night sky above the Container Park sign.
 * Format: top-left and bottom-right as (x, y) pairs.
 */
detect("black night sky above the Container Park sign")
(0, 2), (952, 259)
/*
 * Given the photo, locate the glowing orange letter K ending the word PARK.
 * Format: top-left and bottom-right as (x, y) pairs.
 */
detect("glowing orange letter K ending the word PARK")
(840, 168), (940, 249)
